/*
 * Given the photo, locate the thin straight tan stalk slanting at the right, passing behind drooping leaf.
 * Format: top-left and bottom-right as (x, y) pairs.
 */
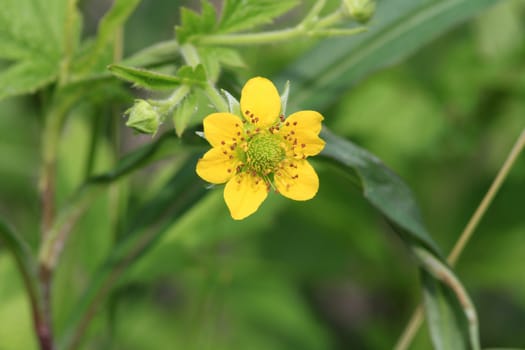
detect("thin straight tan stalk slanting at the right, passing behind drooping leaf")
(394, 129), (525, 350)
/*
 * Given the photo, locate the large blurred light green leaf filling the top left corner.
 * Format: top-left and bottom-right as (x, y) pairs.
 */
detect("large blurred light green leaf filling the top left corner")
(0, 0), (79, 99)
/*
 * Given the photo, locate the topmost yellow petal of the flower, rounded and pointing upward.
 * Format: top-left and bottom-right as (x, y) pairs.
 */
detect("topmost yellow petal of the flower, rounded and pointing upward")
(241, 77), (281, 127)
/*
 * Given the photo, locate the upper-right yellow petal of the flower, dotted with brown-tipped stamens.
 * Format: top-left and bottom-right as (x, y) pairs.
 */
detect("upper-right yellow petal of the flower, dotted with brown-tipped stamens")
(280, 111), (325, 159)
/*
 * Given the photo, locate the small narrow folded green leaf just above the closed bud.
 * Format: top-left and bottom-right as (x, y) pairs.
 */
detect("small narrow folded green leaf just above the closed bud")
(108, 64), (206, 90)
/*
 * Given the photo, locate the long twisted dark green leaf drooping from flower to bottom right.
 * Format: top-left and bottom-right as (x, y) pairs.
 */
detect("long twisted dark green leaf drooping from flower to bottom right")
(321, 129), (479, 349)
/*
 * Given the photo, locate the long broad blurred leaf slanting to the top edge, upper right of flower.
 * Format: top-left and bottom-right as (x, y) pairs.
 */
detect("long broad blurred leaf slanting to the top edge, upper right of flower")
(275, 0), (504, 109)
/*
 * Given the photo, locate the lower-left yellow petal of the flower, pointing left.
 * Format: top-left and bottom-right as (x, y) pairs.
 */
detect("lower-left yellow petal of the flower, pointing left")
(196, 147), (239, 184)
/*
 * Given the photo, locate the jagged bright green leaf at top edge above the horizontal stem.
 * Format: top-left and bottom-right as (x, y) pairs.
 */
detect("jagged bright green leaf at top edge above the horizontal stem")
(175, 0), (299, 44)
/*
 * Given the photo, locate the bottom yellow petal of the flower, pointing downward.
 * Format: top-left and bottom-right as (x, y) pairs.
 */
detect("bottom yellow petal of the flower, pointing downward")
(224, 173), (268, 220)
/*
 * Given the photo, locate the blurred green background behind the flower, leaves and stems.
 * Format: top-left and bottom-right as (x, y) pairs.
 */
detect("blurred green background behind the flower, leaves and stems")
(0, 0), (525, 350)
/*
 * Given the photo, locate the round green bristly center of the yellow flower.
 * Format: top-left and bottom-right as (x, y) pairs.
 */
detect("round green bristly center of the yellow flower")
(246, 134), (285, 175)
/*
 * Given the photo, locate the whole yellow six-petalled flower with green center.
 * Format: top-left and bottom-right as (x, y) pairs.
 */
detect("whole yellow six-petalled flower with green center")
(196, 77), (325, 220)
